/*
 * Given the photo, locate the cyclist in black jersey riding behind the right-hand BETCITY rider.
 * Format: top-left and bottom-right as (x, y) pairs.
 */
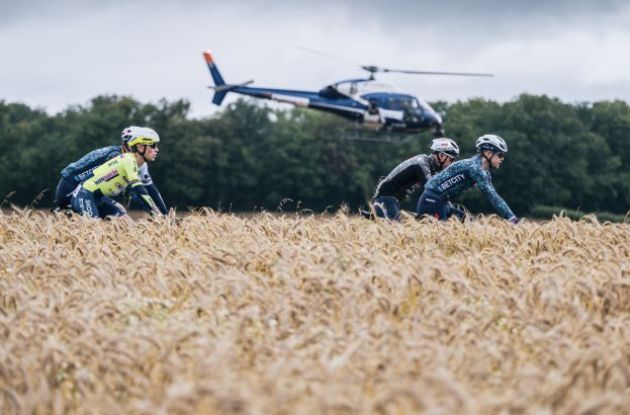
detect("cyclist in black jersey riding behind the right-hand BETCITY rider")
(372, 138), (459, 220)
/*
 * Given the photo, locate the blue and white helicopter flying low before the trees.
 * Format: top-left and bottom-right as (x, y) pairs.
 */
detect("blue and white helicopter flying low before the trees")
(203, 50), (494, 137)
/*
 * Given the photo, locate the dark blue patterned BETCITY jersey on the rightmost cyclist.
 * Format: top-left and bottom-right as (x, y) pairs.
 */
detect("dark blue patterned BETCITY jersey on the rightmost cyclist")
(419, 155), (514, 219)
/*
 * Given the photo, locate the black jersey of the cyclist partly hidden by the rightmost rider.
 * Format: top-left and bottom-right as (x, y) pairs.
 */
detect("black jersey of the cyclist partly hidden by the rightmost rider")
(374, 154), (439, 200)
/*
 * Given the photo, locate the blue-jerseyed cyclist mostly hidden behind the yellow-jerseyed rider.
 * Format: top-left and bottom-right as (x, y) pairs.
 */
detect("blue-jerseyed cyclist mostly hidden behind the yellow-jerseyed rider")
(55, 125), (168, 215)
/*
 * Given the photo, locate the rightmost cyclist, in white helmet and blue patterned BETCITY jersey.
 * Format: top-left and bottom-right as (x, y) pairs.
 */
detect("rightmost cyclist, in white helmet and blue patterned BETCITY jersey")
(416, 134), (518, 223)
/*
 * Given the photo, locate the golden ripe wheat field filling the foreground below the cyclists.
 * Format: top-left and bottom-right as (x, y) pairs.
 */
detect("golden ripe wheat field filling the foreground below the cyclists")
(0, 211), (630, 415)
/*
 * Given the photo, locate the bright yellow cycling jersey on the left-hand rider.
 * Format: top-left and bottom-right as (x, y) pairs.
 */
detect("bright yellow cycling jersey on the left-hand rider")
(83, 153), (140, 197)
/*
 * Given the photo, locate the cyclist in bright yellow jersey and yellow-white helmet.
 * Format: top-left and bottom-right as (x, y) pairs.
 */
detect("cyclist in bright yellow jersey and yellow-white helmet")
(72, 128), (160, 218)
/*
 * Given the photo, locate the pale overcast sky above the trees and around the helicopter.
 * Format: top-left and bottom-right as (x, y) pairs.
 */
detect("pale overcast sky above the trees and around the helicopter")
(0, 0), (630, 117)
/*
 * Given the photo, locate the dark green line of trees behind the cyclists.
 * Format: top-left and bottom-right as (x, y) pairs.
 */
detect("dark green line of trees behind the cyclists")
(0, 95), (630, 215)
